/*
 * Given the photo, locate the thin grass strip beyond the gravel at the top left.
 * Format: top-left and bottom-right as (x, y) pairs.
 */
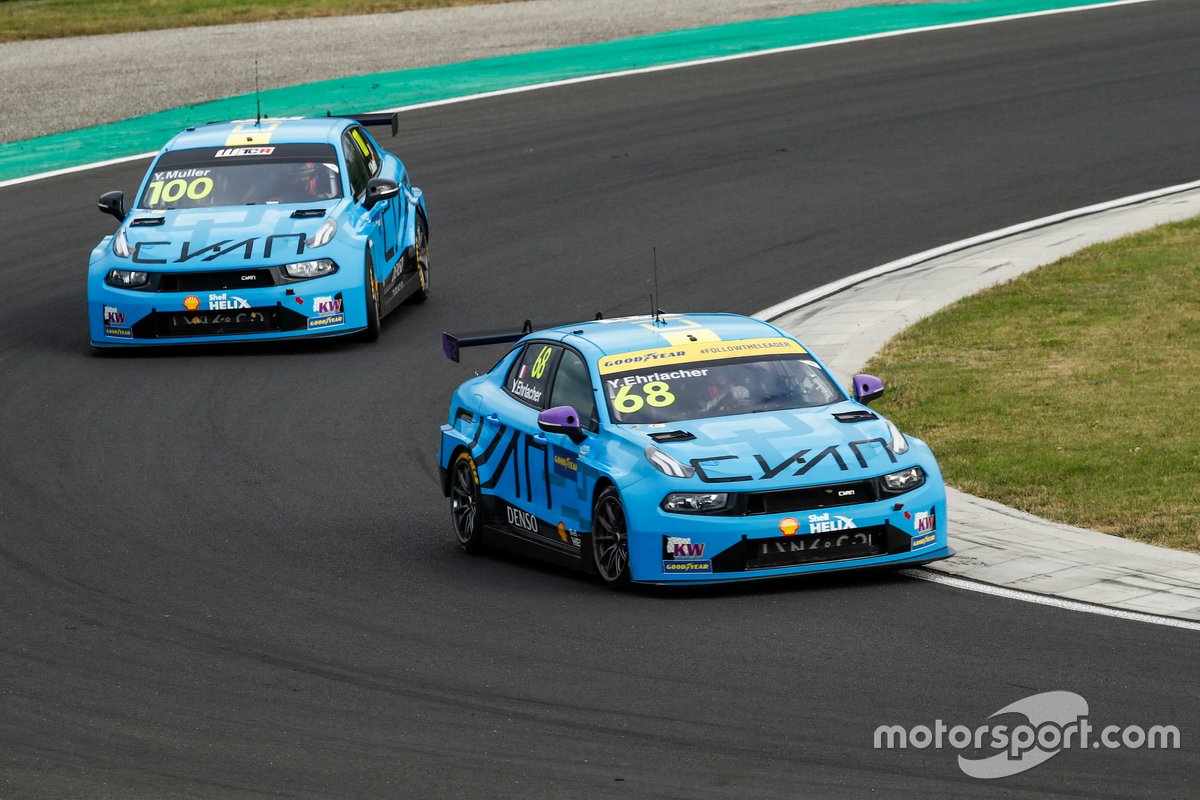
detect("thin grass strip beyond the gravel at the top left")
(0, 0), (503, 42)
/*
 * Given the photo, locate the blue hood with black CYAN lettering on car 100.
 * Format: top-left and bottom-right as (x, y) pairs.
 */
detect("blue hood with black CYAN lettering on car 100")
(124, 200), (338, 270)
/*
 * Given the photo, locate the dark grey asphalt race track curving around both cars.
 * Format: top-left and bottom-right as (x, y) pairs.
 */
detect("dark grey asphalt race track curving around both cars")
(0, 0), (1200, 800)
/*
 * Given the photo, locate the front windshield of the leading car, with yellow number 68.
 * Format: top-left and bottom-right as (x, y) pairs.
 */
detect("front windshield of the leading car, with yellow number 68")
(604, 355), (842, 423)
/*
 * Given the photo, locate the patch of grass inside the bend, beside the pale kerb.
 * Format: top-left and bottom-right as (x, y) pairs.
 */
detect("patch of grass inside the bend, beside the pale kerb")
(866, 219), (1200, 551)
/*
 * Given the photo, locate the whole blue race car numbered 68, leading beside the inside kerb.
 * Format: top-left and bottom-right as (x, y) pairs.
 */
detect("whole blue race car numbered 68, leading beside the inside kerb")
(438, 314), (953, 588)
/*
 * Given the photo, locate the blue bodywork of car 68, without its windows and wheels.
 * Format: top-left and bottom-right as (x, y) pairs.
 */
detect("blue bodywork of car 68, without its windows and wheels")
(439, 314), (952, 583)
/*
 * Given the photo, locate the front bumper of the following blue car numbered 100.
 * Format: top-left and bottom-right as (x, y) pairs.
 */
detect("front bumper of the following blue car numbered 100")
(88, 272), (366, 347)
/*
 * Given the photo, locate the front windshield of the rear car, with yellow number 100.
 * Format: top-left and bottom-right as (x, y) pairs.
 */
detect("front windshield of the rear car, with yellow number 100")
(138, 144), (342, 210)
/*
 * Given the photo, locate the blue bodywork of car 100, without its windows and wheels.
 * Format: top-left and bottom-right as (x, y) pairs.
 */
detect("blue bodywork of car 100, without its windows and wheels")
(88, 118), (428, 348)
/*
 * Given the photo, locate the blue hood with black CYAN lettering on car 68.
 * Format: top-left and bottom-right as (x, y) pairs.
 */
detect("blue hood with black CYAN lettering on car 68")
(625, 402), (902, 491)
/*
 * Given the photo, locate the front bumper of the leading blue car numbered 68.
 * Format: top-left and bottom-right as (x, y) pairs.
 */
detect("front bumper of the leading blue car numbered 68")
(625, 481), (954, 584)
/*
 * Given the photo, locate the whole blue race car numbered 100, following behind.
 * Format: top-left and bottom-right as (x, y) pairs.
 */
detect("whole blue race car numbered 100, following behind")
(88, 114), (430, 348)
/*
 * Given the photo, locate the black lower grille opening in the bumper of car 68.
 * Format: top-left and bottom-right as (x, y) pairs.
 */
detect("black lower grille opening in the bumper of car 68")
(713, 524), (912, 572)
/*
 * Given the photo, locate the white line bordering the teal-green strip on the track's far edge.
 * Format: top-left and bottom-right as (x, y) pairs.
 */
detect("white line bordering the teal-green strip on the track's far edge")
(0, 0), (1156, 188)
